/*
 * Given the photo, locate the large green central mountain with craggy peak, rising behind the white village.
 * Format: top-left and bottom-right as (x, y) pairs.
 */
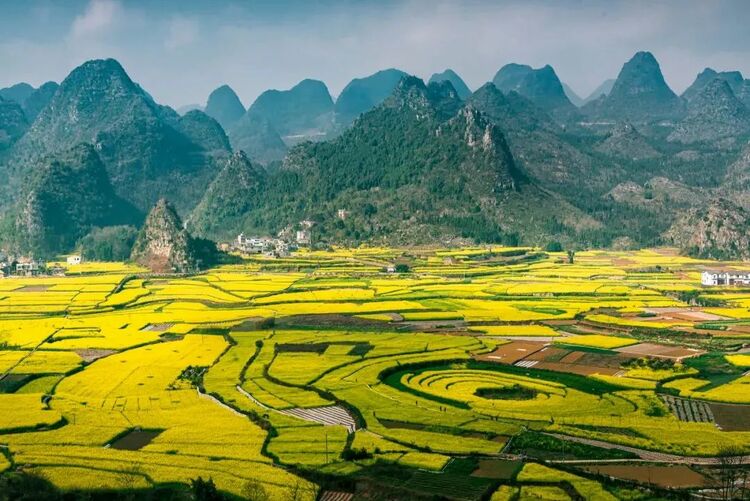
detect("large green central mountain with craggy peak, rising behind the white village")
(191, 77), (600, 243)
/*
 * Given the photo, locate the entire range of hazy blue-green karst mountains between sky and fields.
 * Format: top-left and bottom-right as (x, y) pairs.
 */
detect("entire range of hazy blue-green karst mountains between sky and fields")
(0, 52), (750, 256)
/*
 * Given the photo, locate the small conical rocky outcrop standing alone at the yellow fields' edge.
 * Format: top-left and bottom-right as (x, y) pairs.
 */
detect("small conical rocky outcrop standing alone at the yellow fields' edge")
(130, 198), (198, 273)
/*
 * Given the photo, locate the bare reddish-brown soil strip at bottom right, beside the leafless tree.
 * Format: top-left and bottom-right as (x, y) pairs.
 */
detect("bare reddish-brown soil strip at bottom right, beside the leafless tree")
(583, 465), (708, 488)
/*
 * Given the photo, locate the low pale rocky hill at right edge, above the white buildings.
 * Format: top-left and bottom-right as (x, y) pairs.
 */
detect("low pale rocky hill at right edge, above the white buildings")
(664, 198), (750, 260)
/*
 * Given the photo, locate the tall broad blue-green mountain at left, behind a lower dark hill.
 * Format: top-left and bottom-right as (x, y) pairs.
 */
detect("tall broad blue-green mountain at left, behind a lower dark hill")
(7, 59), (229, 211)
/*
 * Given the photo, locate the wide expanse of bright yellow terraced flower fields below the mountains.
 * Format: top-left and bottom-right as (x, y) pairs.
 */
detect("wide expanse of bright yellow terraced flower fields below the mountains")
(0, 248), (750, 499)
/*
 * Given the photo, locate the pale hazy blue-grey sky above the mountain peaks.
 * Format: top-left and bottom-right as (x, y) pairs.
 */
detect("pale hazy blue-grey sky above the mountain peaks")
(0, 0), (750, 107)
